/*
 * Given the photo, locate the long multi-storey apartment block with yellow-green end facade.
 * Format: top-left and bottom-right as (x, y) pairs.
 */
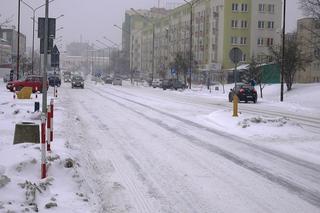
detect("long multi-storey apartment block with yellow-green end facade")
(126, 0), (282, 80)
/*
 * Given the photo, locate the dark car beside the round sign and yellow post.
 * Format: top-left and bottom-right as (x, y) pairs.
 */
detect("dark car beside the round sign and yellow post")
(229, 83), (258, 103)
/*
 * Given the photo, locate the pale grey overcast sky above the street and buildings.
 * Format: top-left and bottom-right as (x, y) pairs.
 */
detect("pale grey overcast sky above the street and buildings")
(0, 0), (302, 50)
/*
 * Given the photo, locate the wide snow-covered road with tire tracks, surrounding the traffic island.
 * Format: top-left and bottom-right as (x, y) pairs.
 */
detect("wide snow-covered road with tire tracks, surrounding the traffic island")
(59, 83), (320, 213)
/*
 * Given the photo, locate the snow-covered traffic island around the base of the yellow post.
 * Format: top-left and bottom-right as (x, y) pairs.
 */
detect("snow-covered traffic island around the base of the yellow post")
(198, 110), (316, 141)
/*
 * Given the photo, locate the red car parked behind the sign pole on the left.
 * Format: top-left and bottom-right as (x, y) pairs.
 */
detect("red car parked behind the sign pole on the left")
(7, 75), (49, 93)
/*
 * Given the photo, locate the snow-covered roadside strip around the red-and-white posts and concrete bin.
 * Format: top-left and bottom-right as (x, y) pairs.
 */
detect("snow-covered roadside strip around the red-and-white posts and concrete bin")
(0, 83), (95, 212)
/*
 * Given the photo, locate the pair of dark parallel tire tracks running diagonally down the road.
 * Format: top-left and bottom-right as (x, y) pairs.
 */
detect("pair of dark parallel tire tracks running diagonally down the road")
(86, 86), (320, 208)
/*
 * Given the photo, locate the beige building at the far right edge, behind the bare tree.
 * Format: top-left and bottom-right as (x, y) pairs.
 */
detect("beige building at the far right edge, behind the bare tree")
(295, 18), (320, 83)
